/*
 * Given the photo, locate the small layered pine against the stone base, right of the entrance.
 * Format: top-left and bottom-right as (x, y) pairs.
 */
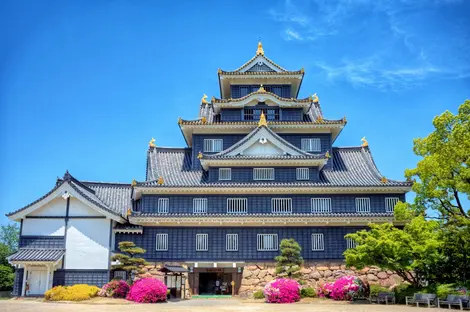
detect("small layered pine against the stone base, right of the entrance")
(275, 238), (304, 278)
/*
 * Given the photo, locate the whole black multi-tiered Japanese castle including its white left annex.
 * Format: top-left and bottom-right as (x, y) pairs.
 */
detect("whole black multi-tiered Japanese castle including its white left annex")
(7, 42), (411, 296)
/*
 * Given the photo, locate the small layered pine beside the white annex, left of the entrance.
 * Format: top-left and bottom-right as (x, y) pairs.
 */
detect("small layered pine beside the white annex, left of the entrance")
(111, 242), (146, 279)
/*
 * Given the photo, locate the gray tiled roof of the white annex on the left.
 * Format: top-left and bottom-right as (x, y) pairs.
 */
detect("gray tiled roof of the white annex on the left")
(6, 171), (131, 216)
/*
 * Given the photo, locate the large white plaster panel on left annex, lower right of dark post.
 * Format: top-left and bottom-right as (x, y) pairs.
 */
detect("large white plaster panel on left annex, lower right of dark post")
(65, 219), (110, 269)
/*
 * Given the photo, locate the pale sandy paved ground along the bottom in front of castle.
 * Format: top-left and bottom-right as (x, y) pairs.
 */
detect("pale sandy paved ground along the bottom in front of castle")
(0, 299), (448, 312)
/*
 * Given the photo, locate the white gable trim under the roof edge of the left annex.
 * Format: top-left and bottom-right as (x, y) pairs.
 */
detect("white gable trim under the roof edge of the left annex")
(7, 181), (124, 223)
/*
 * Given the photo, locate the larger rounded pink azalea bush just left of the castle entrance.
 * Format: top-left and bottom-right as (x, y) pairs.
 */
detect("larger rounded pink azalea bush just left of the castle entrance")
(126, 278), (167, 303)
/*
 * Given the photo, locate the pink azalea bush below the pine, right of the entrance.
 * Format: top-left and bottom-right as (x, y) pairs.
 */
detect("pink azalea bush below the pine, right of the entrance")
(264, 278), (300, 303)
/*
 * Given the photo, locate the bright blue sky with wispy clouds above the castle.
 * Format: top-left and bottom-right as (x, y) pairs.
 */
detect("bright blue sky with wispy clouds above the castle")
(0, 0), (470, 223)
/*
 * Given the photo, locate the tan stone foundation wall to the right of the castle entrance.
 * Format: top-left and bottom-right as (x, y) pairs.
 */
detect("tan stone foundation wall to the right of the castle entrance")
(239, 262), (402, 298)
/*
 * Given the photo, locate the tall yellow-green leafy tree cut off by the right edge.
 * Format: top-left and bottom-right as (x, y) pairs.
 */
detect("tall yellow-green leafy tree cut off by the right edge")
(405, 100), (470, 222)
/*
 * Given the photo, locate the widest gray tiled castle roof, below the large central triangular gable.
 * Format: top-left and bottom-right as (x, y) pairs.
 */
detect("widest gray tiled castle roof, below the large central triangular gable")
(141, 146), (411, 188)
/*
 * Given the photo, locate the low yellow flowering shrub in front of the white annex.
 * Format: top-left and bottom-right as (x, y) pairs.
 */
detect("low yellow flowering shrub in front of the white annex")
(44, 284), (100, 301)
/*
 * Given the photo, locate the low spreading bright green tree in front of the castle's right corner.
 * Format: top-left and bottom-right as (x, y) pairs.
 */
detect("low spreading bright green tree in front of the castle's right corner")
(344, 216), (443, 287)
